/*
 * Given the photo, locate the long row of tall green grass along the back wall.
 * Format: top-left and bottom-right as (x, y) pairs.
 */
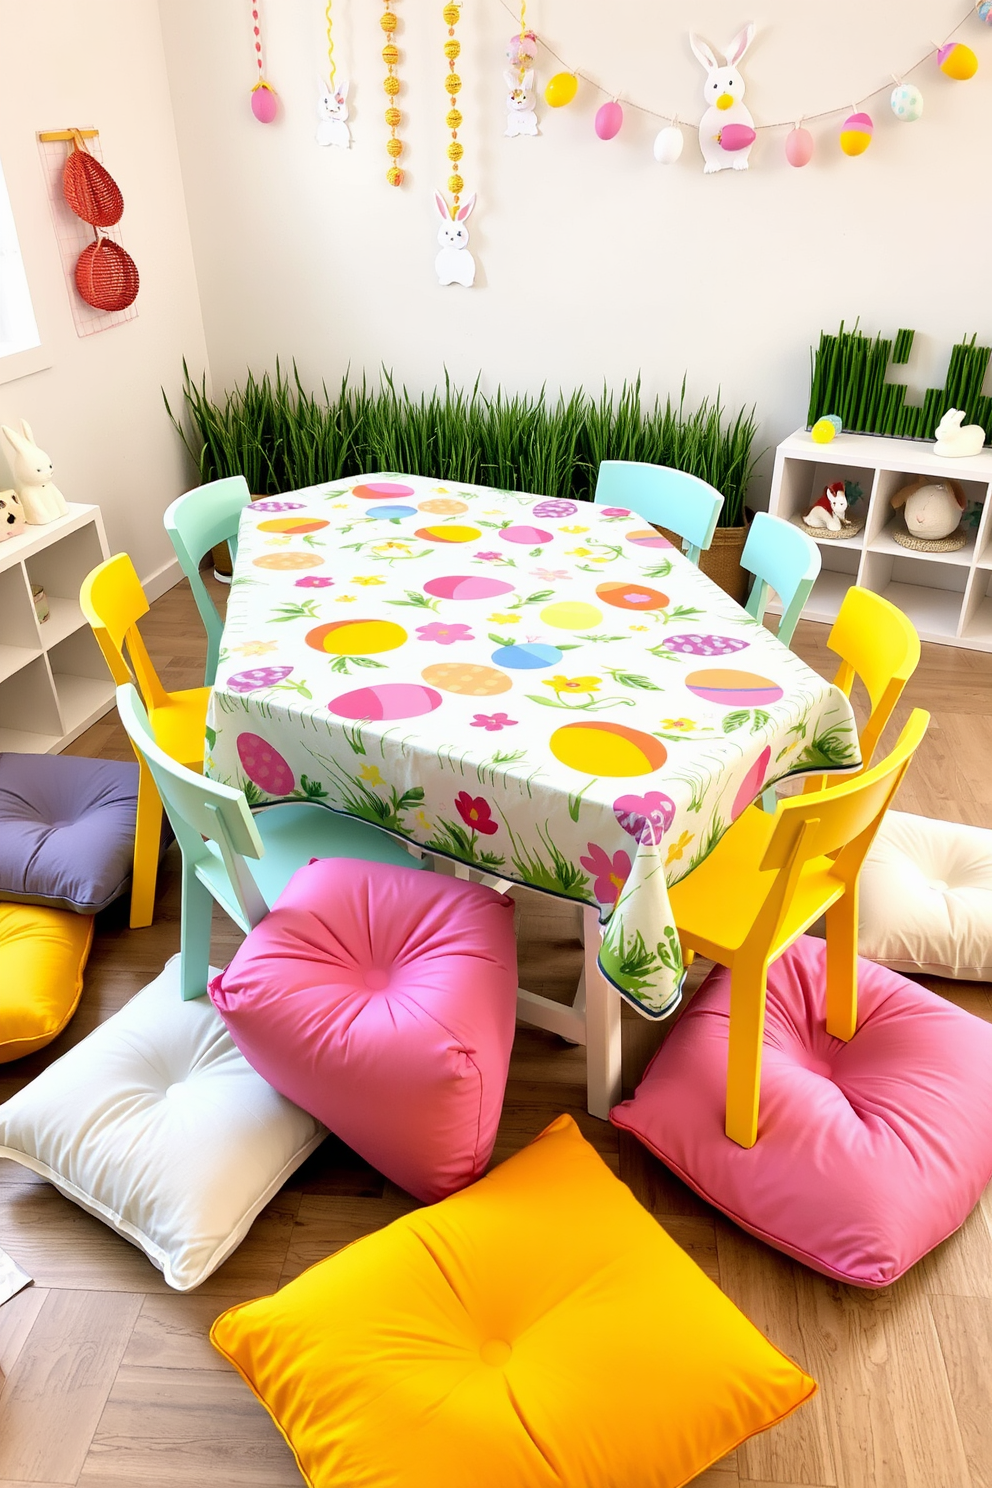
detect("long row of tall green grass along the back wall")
(165, 362), (757, 527)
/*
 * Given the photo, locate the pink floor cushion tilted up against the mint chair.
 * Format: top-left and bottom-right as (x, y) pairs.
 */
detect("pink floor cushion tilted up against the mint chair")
(210, 859), (516, 1201)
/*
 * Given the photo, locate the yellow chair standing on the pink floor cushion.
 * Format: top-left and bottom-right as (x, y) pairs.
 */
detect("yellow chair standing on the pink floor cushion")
(669, 708), (930, 1147)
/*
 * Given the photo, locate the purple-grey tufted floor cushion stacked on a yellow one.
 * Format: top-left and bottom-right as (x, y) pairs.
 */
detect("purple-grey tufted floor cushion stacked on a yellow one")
(0, 754), (138, 915)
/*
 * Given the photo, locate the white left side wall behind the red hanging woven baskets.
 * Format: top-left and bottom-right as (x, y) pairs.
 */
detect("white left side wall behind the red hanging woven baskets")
(0, 0), (207, 591)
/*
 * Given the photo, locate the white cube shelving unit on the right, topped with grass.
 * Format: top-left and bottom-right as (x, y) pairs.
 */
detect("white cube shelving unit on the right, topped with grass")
(769, 429), (992, 650)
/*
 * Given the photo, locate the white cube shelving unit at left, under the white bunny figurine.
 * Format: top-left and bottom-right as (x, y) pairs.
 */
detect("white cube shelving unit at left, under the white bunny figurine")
(0, 501), (115, 754)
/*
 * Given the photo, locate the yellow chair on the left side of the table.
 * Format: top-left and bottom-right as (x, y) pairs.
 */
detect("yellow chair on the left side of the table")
(79, 554), (210, 930)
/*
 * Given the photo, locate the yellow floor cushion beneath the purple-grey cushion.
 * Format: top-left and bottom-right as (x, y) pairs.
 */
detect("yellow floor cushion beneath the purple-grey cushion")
(0, 905), (94, 1064)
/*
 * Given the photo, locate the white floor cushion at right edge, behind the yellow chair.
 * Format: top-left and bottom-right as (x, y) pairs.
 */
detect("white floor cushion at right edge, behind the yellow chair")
(858, 811), (992, 982)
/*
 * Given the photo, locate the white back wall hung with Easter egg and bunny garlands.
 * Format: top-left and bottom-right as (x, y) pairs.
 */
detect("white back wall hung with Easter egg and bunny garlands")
(161, 0), (992, 499)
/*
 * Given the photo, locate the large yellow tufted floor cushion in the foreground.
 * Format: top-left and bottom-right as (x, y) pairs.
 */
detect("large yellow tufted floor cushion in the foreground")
(210, 1116), (817, 1488)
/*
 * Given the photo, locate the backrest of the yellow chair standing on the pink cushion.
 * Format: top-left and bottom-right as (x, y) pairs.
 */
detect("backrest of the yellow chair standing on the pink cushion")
(751, 708), (930, 945)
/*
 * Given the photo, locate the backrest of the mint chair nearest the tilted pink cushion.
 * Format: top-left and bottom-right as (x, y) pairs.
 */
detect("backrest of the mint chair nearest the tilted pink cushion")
(117, 682), (268, 929)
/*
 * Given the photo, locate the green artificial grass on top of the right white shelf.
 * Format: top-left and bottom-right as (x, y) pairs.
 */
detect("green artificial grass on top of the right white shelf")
(806, 321), (992, 443)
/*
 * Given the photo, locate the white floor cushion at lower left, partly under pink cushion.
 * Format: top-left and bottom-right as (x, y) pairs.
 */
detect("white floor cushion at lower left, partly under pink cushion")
(0, 957), (327, 1292)
